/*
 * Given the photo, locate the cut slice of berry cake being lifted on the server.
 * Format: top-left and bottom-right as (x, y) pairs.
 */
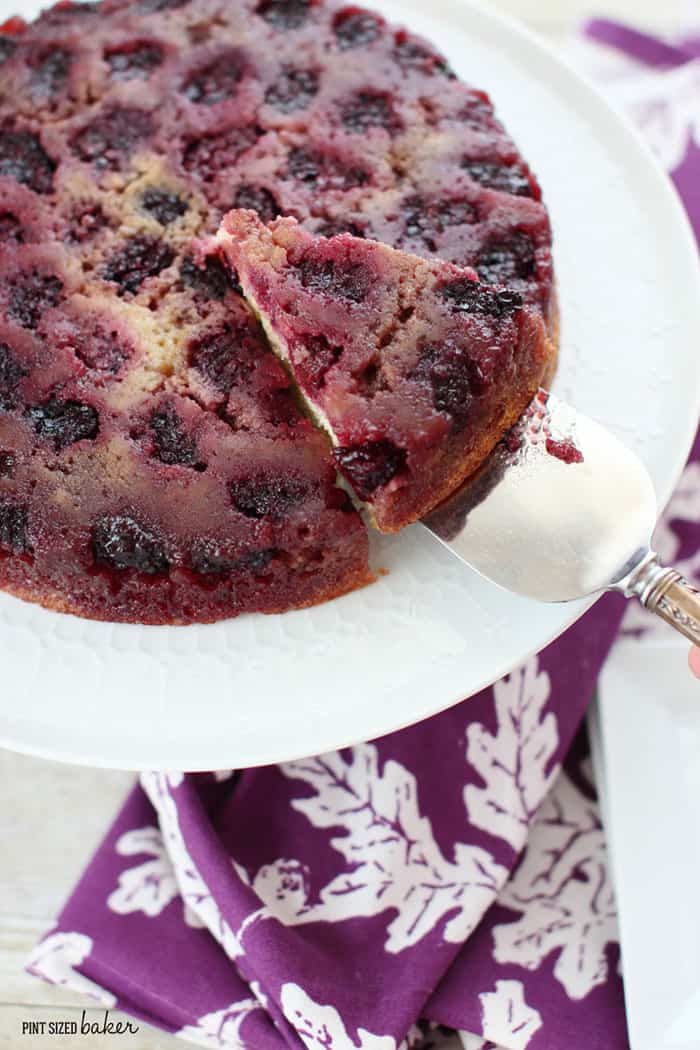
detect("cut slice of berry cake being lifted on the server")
(215, 210), (554, 532)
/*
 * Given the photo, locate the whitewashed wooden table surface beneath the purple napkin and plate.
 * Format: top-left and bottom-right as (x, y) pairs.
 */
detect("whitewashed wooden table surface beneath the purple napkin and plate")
(0, 0), (688, 1050)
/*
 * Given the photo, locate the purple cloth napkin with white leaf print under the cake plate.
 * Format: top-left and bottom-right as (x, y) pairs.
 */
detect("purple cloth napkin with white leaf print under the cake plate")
(29, 21), (700, 1050)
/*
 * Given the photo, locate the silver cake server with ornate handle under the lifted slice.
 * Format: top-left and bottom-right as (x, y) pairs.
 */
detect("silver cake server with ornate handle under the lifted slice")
(423, 390), (700, 644)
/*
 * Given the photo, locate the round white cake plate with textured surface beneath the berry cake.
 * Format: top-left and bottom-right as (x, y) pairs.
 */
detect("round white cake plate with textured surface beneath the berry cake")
(0, 0), (700, 770)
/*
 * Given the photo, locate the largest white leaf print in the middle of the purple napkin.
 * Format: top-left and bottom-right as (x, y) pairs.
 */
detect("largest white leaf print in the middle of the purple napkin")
(277, 744), (507, 952)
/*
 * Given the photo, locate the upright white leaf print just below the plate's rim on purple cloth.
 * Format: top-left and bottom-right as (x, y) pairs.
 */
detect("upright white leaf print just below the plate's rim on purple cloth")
(464, 656), (558, 852)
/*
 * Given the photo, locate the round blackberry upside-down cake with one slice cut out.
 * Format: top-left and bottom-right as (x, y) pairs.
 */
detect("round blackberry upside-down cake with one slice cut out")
(0, 0), (554, 624)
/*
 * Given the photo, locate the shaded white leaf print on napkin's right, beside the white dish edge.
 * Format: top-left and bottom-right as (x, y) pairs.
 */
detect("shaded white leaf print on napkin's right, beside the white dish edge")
(493, 773), (618, 1000)
